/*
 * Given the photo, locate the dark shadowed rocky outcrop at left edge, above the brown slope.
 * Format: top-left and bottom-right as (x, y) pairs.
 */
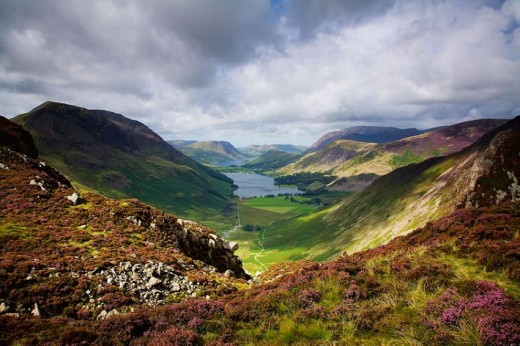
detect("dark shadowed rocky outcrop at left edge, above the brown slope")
(0, 116), (38, 159)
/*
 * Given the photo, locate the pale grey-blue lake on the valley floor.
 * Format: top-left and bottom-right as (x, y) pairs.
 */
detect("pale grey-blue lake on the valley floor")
(224, 173), (302, 198)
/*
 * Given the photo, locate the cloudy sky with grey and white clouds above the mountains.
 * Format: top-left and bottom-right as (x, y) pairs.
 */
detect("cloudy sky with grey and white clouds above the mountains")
(0, 0), (520, 147)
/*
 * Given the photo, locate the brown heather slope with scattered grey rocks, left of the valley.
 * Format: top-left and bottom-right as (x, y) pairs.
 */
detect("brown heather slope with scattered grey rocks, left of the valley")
(0, 119), (248, 330)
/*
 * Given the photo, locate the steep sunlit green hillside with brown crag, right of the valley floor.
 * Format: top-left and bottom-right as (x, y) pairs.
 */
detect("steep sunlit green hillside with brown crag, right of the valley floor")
(262, 117), (520, 259)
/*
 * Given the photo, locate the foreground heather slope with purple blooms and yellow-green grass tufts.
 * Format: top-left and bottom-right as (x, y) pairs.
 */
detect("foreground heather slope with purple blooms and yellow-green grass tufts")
(0, 196), (520, 345)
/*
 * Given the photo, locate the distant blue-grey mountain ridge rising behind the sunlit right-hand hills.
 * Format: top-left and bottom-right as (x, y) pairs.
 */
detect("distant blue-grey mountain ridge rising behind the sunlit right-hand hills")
(307, 126), (423, 152)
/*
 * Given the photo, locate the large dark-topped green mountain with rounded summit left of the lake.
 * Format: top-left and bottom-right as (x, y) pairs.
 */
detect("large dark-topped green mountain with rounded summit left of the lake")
(13, 102), (232, 218)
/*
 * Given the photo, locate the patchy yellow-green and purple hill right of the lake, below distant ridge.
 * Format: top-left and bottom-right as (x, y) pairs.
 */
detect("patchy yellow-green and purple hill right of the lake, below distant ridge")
(278, 119), (506, 189)
